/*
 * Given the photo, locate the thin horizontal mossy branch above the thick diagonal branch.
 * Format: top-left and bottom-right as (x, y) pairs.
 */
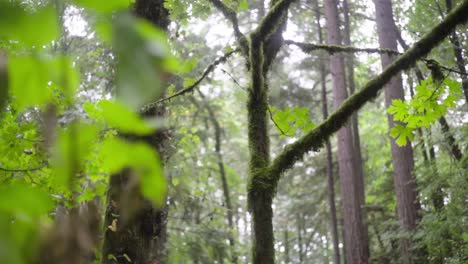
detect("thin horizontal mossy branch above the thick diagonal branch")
(284, 40), (401, 55)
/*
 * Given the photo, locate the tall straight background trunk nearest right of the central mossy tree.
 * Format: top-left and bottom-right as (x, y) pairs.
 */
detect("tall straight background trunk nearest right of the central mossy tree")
(325, 0), (369, 264)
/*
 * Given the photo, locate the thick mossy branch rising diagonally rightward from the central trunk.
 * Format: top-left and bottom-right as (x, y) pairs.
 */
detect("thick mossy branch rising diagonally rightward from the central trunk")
(268, 0), (468, 182)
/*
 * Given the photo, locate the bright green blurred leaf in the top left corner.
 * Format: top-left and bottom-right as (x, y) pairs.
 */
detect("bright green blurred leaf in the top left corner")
(0, 1), (59, 47)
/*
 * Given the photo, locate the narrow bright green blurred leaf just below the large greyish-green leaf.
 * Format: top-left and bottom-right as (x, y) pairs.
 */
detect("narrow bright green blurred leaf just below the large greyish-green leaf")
(98, 100), (154, 135)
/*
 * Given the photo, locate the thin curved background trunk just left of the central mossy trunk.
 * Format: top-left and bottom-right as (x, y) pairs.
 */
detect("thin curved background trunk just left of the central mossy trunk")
(198, 90), (237, 263)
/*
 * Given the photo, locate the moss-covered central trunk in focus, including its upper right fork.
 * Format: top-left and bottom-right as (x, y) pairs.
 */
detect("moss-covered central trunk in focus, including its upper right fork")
(247, 0), (293, 264)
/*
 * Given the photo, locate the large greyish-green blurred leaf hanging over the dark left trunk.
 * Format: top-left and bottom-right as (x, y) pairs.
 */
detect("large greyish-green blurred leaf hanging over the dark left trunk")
(114, 14), (179, 110)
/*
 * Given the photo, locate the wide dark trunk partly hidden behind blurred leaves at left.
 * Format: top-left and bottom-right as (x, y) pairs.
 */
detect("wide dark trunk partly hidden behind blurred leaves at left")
(102, 0), (169, 264)
